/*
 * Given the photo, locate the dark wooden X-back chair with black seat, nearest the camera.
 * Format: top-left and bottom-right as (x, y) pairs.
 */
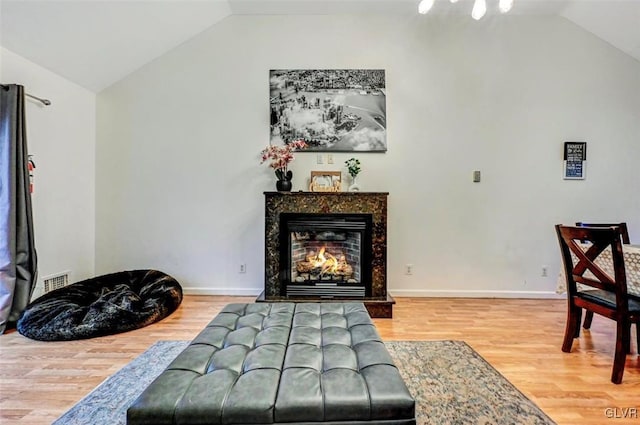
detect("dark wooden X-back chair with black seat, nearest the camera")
(556, 225), (640, 384)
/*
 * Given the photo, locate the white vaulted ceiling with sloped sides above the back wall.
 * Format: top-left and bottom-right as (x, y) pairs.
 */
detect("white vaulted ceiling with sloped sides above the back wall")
(0, 0), (640, 92)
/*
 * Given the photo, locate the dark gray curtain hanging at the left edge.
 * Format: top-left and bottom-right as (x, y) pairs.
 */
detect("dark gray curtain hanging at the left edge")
(0, 84), (37, 333)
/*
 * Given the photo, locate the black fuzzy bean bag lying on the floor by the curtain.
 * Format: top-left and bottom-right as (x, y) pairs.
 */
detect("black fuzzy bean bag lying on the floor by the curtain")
(17, 270), (182, 341)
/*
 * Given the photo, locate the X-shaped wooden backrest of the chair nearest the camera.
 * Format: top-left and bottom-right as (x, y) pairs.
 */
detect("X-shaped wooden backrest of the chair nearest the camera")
(556, 224), (628, 312)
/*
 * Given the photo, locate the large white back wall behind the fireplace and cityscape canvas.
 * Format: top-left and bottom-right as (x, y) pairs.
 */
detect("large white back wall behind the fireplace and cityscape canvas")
(96, 15), (640, 297)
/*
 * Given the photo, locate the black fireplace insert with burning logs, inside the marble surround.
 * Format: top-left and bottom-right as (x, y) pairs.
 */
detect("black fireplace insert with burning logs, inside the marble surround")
(280, 213), (372, 299)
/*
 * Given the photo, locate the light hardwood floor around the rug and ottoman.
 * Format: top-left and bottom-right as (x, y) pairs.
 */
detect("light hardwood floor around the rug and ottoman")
(0, 296), (640, 425)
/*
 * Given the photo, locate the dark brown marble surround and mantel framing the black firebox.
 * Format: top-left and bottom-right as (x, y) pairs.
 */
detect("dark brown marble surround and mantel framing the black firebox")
(257, 192), (395, 318)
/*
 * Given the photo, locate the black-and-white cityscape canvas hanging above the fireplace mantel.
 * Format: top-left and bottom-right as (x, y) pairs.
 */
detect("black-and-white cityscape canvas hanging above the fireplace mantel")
(269, 69), (387, 152)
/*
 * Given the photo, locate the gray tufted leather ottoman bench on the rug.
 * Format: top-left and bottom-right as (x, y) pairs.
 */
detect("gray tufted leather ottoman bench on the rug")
(127, 303), (416, 425)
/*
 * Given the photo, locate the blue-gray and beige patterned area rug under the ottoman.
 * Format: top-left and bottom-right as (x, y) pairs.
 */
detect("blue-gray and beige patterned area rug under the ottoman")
(54, 341), (555, 425)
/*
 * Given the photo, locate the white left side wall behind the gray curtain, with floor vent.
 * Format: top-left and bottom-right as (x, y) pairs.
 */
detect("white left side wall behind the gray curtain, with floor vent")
(0, 48), (96, 297)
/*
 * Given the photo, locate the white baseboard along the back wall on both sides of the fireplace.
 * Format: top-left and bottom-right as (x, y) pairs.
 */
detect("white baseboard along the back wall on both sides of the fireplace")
(182, 287), (566, 299)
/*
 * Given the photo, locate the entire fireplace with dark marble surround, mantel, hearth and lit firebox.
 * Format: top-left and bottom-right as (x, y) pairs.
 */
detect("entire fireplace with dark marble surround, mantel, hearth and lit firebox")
(256, 191), (395, 318)
